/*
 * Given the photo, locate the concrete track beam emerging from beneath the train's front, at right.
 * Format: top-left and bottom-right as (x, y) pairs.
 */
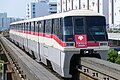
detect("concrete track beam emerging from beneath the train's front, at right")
(78, 57), (120, 80)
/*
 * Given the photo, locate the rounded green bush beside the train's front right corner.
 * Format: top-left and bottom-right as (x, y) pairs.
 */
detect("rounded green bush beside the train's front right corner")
(107, 49), (118, 63)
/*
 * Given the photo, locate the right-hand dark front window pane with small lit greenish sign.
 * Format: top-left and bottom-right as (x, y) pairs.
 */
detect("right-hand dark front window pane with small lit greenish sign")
(86, 16), (107, 41)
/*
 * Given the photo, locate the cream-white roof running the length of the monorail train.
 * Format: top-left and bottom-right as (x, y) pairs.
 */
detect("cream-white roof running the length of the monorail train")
(10, 9), (103, 25)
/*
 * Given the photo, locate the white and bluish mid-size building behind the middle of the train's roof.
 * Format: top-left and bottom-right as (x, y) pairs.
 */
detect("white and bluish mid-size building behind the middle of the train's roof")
(26, 0), (57, 19)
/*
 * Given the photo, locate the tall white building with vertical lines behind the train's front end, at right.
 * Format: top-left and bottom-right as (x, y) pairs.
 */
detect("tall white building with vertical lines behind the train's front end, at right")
(57, 0), (120, 25)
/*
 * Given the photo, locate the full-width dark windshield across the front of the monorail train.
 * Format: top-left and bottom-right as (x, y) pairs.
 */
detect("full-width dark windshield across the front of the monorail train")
(63, 16), (108, 41)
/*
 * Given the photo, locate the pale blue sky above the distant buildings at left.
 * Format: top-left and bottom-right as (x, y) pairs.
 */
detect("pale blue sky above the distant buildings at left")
(0, 0), (56, 18)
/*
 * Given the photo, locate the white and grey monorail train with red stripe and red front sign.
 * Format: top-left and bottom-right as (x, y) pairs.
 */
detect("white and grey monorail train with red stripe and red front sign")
(10, 9), (109, 78)
